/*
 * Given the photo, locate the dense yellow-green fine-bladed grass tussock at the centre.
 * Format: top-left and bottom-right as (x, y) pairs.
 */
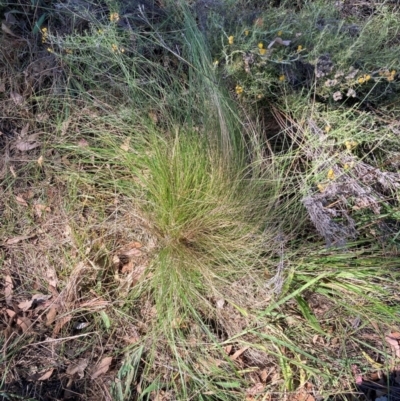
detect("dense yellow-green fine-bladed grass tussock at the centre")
(134, 132), (274, 320)
